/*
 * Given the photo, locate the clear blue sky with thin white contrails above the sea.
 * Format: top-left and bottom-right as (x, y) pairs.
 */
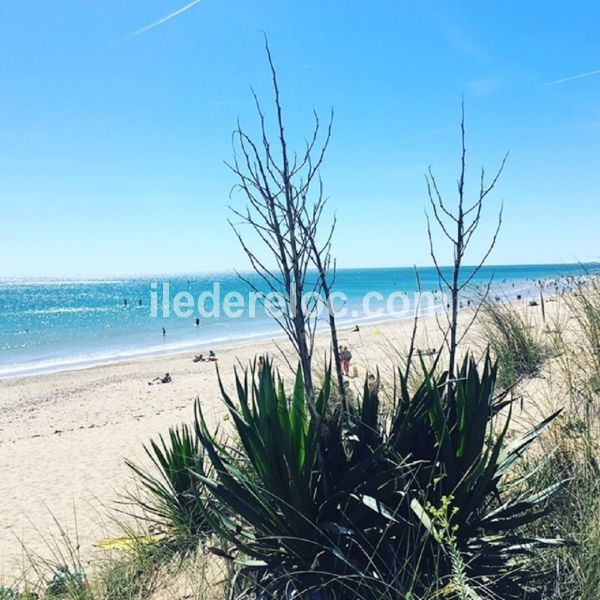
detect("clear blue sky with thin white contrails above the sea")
(0, 0), (600, 276)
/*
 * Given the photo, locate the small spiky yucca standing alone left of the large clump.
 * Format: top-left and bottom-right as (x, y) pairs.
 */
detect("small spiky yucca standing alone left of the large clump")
(126, 425), (212, 549)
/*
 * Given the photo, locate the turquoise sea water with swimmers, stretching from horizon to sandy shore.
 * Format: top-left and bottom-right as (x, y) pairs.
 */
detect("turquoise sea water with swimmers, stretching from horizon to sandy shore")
(0, 264), (583, 378)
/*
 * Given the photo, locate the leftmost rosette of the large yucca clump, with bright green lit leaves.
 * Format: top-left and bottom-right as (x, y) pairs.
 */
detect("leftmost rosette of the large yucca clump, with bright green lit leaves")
(196, 363), (329, 596)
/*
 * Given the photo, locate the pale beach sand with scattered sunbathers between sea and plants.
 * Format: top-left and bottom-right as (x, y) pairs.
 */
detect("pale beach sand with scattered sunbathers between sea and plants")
(0, 302), (558, 578)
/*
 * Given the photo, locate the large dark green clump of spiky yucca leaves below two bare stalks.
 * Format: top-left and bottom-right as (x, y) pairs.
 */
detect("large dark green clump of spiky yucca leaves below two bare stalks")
(185, 355), (564, 600)
